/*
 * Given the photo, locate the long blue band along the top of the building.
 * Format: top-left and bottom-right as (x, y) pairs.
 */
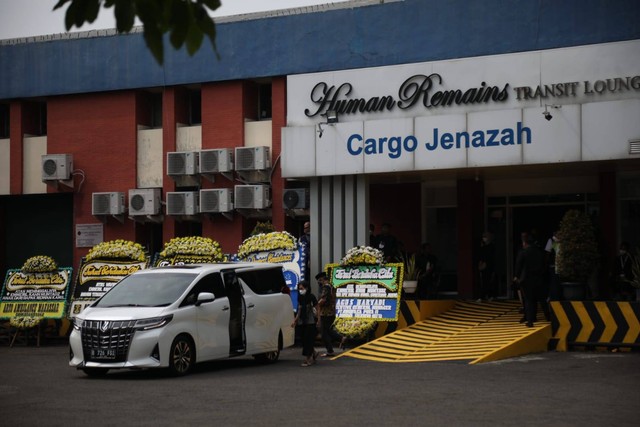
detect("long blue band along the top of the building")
(0, 0), (640, 99)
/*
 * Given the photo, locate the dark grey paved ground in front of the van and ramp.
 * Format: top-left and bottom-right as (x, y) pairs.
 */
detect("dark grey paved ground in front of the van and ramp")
(0, 345), (640, 427)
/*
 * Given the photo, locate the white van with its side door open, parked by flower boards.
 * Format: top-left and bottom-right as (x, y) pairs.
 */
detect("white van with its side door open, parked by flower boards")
(69, 263), (294, 376)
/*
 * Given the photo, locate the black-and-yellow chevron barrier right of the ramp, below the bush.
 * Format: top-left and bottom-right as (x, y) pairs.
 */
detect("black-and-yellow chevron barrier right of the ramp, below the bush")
(549, 301), (640, 351)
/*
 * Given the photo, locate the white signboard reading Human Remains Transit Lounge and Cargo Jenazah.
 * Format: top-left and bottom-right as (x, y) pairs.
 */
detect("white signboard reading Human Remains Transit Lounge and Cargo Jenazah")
(282, 41), (640, 178)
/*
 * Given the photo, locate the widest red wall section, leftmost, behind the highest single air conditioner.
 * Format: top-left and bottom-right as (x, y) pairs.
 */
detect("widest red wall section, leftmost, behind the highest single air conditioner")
(47, 92), (137, 265)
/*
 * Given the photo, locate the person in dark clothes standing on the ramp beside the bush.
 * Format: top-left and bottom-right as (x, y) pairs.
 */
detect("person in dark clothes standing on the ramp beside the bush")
(513, 235), (545, 327)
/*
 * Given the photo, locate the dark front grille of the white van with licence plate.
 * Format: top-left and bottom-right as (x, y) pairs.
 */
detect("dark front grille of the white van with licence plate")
(82, 320), (136, 362)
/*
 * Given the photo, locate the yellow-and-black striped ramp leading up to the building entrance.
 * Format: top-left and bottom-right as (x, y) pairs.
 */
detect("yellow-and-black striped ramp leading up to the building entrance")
(337, 301), (551, 364)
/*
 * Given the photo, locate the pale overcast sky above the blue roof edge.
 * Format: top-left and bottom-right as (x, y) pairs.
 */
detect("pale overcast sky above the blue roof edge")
(0, 0), (345, 40)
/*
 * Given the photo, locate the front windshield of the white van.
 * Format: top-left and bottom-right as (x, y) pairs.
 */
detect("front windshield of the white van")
(95, 272), (197, 307)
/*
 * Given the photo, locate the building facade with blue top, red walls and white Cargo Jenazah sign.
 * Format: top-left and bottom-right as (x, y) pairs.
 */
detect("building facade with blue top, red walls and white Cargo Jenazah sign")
(0, 0), (640, 297)
